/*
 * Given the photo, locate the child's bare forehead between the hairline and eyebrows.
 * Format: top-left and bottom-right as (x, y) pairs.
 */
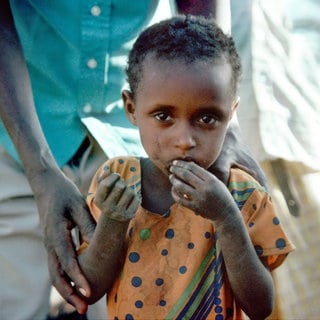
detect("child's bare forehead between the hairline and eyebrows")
(138, 57), (232, 100)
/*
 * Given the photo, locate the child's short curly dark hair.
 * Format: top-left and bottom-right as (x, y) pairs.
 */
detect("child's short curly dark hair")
(126, 15), (241, 98)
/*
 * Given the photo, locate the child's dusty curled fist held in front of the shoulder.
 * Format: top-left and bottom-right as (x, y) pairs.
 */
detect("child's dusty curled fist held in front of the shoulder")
(94, 173), (139, 222)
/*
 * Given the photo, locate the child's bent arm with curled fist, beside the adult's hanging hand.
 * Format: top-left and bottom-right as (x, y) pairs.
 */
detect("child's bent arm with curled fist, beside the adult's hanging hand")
(79, 174), (139, 304)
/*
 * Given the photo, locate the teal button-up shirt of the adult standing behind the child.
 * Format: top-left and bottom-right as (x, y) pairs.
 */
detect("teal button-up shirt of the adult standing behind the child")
(0, 0), (170, 165)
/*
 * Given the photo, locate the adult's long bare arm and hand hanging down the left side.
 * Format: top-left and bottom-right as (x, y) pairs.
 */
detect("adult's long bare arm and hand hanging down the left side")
(0, 0), (95, 311)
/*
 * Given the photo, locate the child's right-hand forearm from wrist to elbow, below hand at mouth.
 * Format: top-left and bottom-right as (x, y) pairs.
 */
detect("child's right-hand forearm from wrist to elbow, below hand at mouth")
(214, 205), (274, 319)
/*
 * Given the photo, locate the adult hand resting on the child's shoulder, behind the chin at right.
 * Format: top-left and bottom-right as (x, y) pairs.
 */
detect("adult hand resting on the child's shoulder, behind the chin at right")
(210, 122), (267, 187)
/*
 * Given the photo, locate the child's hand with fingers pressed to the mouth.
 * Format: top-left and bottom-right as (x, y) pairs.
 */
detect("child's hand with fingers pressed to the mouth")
(170, 160), (236, 221)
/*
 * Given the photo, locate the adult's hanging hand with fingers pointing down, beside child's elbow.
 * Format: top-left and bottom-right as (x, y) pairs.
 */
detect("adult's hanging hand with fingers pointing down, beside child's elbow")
(33, 171), (95, 314)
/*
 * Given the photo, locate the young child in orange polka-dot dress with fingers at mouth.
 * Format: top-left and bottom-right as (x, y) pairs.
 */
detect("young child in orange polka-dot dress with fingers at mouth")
(79, 16), (293, 319)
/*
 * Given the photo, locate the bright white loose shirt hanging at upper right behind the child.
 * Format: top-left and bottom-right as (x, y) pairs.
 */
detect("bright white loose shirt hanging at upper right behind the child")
(232, 0), (320, 170)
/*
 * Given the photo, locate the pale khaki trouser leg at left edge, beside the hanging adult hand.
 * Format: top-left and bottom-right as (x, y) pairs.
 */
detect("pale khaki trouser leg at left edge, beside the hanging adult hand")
(0, 146), (50, 320)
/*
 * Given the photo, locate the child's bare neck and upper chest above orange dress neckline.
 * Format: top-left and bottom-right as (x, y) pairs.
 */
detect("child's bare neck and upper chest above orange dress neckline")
(141, 158), (174, 214)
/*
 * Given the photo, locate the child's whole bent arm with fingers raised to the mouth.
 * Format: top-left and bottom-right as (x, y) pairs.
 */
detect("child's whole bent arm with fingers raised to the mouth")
(170, 161), (274, 319)
